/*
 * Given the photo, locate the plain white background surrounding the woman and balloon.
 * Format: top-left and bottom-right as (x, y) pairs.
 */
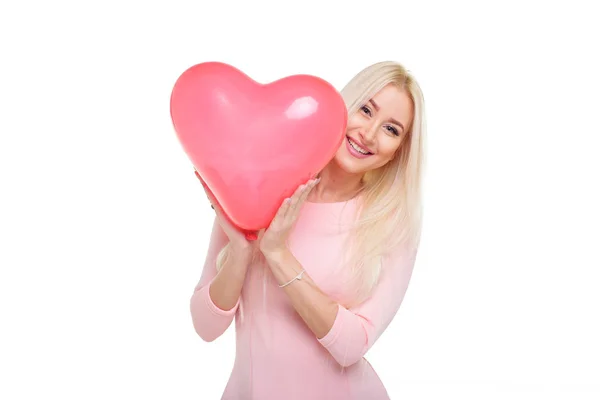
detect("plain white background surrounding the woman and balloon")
(0, 0), (600, 400)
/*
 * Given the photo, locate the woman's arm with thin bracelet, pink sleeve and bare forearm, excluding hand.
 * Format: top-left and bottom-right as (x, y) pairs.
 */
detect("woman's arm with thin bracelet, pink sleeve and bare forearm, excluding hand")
(265, 242), (416, 367)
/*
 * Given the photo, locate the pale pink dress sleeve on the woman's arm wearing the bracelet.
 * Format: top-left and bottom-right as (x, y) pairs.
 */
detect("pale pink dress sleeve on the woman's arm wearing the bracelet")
(318, 242), (417, 367)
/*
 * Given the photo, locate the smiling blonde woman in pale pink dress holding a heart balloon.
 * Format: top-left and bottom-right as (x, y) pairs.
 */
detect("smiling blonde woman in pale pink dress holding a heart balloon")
(190, 62), (425, 400)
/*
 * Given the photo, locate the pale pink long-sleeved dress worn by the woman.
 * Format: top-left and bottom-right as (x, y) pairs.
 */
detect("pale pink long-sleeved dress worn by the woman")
(190, 200), (416, 400)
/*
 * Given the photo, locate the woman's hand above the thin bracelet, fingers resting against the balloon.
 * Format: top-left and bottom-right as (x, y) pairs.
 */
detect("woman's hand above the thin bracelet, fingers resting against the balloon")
(259, 178), (321, 257)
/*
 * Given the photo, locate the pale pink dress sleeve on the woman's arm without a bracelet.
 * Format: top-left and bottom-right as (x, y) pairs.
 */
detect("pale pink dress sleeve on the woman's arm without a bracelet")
(190, 218), (240, 342)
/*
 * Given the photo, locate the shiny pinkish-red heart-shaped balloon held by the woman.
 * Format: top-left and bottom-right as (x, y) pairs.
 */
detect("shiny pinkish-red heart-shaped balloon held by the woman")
(171, 62), (347, 236)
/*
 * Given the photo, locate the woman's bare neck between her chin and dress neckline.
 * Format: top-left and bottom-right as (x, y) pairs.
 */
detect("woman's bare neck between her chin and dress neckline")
(309, 160), (363, 203)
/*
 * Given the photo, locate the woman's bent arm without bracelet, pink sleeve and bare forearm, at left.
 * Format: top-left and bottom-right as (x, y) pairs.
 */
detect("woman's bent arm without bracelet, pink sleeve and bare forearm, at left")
(190, 218), (251, 342)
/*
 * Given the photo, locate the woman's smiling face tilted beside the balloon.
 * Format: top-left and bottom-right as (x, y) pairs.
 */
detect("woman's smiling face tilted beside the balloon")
(334, 84), (413, 174)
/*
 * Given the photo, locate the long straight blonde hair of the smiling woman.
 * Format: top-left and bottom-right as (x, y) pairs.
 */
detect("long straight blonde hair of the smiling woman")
(217, 61), (425, 307)
